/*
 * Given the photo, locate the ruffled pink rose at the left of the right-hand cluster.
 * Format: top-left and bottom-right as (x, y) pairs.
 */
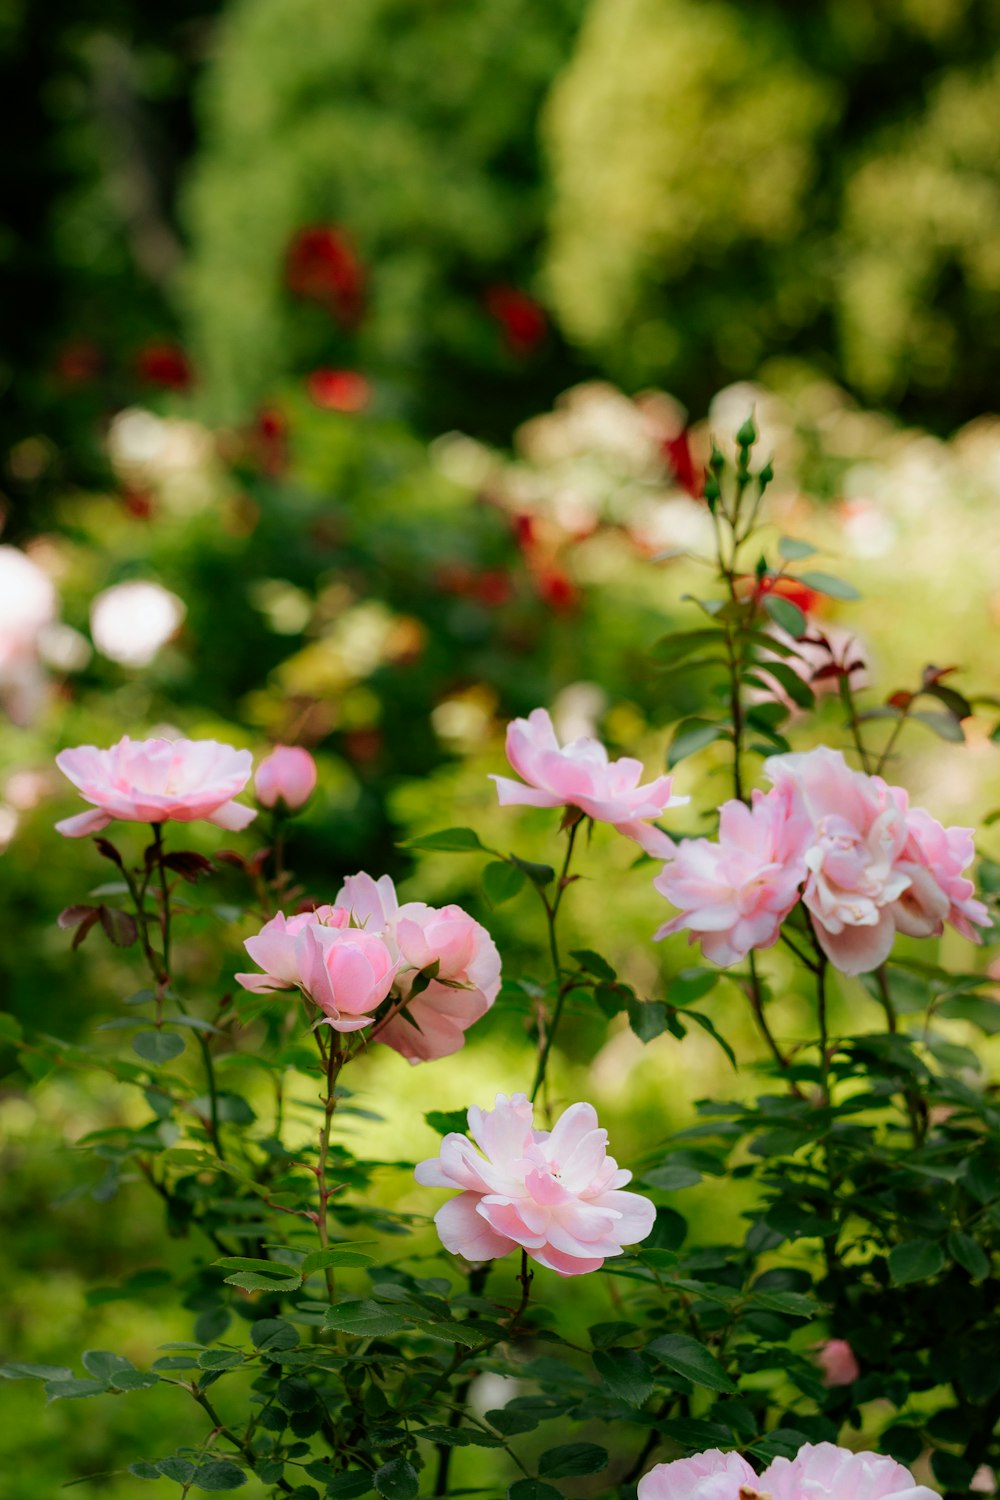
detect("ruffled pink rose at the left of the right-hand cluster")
(652, 791), (810, 968)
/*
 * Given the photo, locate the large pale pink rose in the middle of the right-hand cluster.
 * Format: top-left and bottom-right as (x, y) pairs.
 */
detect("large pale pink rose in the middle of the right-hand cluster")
(765, 746), (912, 974)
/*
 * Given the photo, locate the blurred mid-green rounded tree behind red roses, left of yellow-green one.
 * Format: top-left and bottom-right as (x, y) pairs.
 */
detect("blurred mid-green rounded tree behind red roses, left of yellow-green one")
(184, 0), (583, 435)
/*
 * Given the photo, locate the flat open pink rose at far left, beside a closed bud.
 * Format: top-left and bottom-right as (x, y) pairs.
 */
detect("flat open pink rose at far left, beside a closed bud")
(55, 735), (256, 839)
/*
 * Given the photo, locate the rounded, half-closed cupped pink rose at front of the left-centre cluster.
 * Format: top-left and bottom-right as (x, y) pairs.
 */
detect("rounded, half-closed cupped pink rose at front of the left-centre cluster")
(295, 923), (396, 1032)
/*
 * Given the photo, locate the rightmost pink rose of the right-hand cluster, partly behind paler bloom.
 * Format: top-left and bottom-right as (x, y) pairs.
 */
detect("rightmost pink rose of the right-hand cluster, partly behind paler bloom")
(894, 807), (993, 942)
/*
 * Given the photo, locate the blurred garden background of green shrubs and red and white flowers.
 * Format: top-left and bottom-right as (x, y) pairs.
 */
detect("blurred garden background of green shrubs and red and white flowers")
(0, 0), (1000, 1500)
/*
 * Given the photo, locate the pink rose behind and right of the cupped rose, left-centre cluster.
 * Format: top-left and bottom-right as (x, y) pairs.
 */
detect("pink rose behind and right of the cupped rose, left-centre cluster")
(337, 873), (501, 1062)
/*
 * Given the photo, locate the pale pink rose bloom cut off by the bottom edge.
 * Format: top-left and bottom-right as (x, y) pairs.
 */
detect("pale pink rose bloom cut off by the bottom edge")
(637, 1443), (939, 1500)
